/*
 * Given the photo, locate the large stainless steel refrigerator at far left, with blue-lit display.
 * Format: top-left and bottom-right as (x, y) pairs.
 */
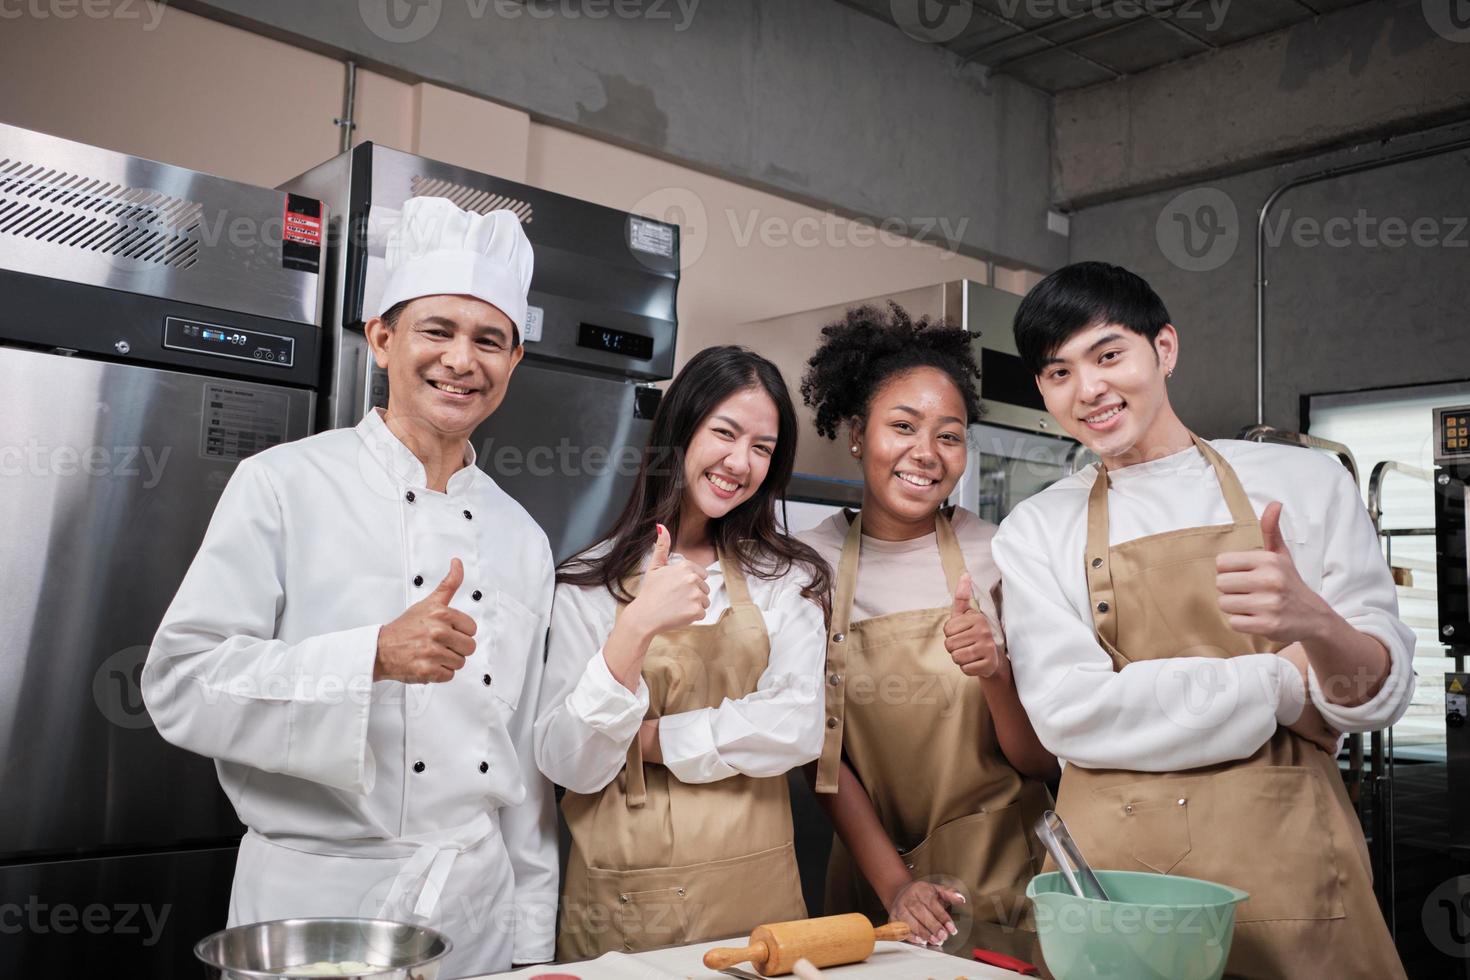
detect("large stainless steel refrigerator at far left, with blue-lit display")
(0, 125), (323, 977)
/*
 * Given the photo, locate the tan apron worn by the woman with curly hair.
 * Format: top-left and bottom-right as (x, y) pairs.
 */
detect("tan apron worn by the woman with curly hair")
(816, 513), (1051, 956)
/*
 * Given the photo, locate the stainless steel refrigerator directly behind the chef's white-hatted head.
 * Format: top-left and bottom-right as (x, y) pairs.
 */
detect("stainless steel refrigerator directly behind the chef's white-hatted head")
(282, 143), (679, 561)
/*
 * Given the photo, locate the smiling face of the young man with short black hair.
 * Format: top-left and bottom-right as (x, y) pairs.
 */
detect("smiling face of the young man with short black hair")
(1036, 323), (1188, 469)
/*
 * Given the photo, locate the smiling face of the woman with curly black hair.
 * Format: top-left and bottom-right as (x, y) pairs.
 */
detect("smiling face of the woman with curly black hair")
(853, 367), (966, 533)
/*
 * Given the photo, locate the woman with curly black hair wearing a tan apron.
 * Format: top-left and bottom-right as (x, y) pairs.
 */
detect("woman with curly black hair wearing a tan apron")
(800, 303), (1057, 959)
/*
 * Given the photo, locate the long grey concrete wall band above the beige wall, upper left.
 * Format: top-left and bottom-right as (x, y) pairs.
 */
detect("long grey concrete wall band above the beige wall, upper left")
(169, 0), (1067, 269)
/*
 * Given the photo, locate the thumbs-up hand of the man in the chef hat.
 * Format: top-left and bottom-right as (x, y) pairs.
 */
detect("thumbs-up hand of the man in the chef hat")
(372, 558), (475, 683)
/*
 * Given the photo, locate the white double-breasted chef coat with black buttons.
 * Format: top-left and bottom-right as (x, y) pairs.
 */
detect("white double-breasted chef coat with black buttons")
(143, 411), (557, 976)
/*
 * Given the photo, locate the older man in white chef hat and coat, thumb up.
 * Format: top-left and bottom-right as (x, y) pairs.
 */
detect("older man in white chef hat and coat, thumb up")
(143, 197), (557, 976)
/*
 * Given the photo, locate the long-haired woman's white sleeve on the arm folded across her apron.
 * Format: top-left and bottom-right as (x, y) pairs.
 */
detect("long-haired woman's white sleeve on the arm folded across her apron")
(659, 576), (826, 783)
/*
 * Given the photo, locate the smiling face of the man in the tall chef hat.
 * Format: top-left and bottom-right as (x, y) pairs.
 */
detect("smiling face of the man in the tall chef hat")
(366, 295), (525, 439)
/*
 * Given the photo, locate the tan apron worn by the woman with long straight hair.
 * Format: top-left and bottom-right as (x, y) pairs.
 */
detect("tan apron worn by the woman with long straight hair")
(557, 554), (807, 961)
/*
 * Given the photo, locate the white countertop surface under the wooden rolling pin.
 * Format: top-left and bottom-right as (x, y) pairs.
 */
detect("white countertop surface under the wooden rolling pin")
(475, 937), (1019, 980)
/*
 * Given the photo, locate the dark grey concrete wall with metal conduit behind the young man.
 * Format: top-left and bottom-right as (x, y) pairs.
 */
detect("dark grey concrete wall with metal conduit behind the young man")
(1072, 125), (1470, 436)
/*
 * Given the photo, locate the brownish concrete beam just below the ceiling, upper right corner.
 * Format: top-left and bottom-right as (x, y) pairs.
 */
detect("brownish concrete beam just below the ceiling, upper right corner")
(1053, 0), (1470, 207)
